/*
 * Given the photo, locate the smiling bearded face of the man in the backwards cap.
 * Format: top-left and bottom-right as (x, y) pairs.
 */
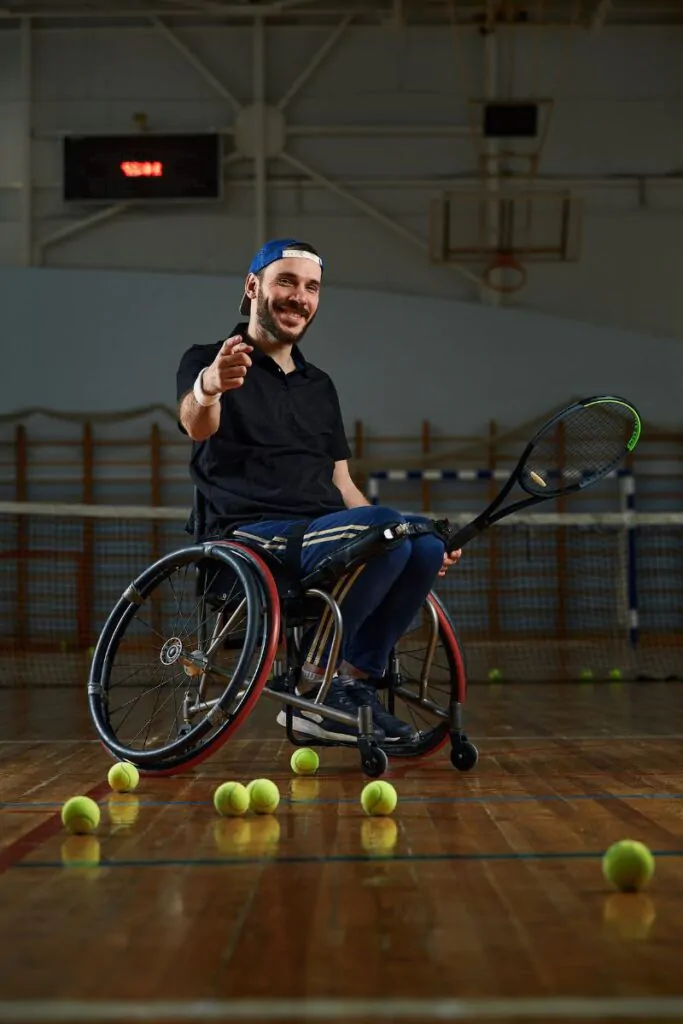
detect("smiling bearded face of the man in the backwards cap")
(250, 256), (322, 345)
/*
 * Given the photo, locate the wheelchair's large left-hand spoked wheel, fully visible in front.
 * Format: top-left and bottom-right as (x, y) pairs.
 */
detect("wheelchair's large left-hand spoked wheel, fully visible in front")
(88, 543), (280, 774)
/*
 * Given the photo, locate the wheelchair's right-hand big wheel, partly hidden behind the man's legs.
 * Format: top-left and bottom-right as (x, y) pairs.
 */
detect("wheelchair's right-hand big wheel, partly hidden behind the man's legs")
(380, 593), (467, 760)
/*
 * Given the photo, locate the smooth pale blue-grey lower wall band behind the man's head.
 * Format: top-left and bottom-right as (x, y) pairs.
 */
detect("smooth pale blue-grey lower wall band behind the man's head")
(0, 268), (683, 434)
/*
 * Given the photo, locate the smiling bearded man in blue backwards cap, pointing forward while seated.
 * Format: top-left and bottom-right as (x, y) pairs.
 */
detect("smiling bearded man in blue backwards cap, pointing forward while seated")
(177, 239), (460, 741)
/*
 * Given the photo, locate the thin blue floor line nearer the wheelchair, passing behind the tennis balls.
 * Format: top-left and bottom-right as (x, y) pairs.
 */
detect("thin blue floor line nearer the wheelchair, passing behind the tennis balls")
(0, 793), (683, 810)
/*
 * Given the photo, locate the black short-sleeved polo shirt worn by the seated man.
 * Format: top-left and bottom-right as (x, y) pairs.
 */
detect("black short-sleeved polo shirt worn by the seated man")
(177, 324), (351, 531)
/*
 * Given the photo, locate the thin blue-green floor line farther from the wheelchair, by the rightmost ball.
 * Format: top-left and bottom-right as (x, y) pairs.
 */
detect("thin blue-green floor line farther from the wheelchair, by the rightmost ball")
(10, 850), (683, 870)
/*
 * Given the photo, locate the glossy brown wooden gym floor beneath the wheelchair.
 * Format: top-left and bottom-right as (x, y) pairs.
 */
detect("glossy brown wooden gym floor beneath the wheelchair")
(0, 683), (683, 1024)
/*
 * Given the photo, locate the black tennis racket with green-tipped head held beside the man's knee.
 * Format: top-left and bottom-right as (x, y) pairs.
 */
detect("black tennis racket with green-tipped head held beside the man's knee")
(446, 395), (641, 553)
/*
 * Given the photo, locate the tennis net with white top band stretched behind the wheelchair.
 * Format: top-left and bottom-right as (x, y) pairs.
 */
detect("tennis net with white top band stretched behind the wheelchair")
(0, 502), (683, 686)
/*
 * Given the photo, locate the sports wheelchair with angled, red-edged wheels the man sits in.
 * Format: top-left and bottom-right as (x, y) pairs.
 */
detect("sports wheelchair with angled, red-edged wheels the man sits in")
(88, 492), (478, 778)
